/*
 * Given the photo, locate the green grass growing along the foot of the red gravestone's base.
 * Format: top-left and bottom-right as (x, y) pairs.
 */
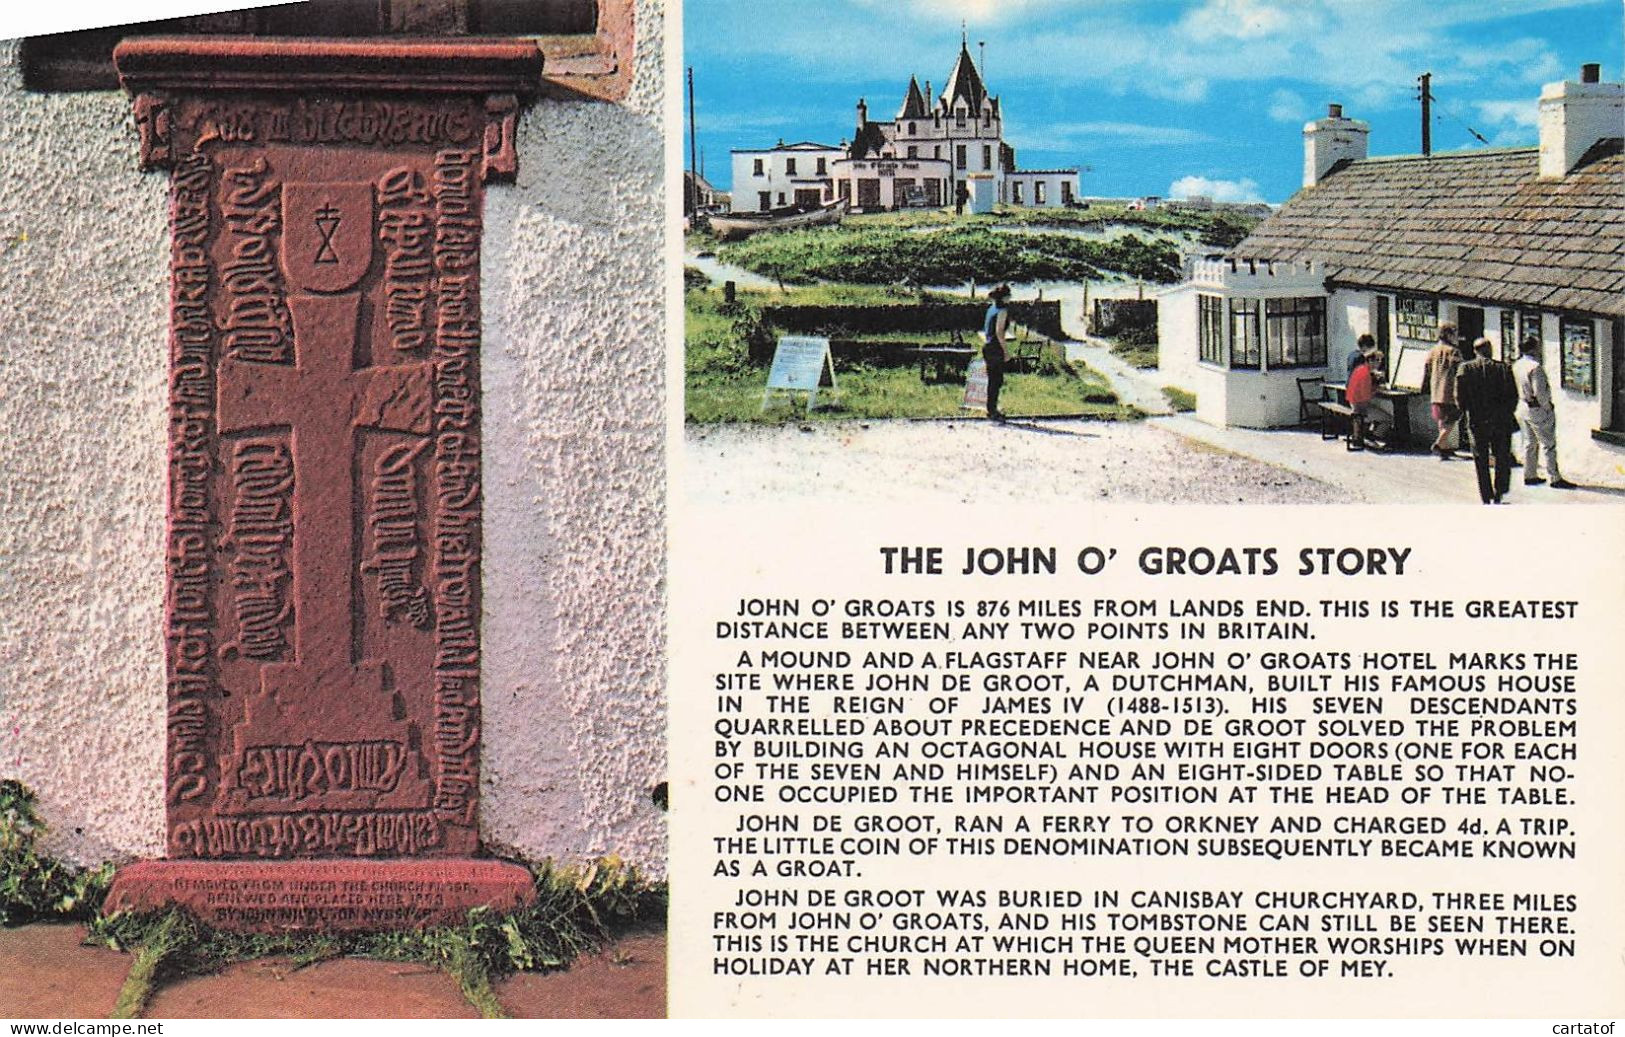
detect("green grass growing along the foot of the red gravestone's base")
(89, 858), (666, 1017)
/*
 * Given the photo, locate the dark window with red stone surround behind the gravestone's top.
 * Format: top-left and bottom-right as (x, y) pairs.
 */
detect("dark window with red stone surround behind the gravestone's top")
(21, 0), (635, 101)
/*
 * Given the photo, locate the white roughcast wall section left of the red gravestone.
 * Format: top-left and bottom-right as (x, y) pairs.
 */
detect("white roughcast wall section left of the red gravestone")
(0, 42), (169, 861)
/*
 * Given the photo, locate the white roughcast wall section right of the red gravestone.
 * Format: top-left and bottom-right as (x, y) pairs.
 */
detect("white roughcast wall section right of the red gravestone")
(481, 0), (666, 874)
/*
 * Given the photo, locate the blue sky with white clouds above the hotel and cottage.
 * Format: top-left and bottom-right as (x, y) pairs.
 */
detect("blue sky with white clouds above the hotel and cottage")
(683, 0), (1625, 202)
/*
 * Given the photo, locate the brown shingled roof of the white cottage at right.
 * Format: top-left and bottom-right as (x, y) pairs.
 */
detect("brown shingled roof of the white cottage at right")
(1233, 140), (1625, 317)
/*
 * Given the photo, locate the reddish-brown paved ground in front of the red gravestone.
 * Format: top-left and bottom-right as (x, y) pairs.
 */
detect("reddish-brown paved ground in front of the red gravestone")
(0, 925), (666, 1019)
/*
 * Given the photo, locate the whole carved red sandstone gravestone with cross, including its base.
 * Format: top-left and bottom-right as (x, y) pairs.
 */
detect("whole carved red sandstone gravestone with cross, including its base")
(109, 37), (541, 928)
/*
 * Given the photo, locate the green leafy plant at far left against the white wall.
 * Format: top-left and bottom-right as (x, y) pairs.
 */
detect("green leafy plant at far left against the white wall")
(0, 779), (112, 925)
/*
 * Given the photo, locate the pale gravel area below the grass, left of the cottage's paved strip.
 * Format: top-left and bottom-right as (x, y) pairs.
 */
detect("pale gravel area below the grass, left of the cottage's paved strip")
(684, 419), (1357, 504)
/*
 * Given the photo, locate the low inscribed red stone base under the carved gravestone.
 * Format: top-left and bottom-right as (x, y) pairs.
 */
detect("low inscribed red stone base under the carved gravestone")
(102, 858), (536, 933)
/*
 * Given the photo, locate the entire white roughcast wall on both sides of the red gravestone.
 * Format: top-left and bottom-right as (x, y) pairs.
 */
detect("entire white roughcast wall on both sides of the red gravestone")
(0, 0), (666, 876)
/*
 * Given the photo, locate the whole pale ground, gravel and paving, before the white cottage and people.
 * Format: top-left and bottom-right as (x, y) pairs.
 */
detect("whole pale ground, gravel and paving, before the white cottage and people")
(683, 416), (1625, 505)
